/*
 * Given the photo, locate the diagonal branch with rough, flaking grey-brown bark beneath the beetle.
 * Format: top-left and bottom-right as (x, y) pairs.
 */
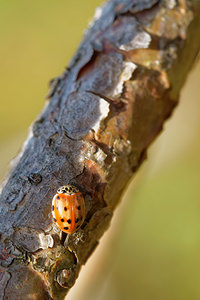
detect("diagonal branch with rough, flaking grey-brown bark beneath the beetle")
(0, 0), (200, 299)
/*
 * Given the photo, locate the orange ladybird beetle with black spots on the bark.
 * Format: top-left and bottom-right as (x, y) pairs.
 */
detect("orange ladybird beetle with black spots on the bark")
(52, 185), (85, 234)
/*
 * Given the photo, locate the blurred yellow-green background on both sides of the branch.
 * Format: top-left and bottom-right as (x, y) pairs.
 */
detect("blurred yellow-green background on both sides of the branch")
(0, 0), (200, 300)
